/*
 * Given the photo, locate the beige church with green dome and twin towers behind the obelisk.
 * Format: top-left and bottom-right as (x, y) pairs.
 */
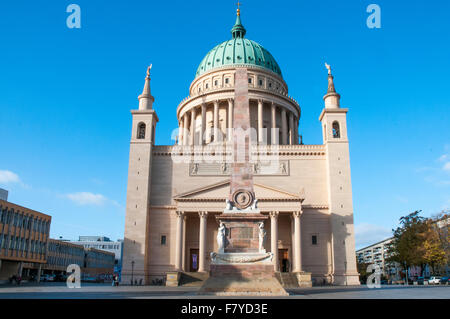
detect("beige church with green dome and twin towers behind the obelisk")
(122, 9), (359, 285)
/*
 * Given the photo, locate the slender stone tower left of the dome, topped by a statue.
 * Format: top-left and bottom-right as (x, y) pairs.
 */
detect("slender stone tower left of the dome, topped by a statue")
(121, 66), (158, 284)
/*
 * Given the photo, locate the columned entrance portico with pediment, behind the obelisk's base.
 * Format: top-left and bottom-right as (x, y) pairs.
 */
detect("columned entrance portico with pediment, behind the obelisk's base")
(174, 181), (303, 272)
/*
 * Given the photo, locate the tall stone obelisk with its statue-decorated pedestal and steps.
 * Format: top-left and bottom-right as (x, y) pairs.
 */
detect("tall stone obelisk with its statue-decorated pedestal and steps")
(198, 68), (288, 296)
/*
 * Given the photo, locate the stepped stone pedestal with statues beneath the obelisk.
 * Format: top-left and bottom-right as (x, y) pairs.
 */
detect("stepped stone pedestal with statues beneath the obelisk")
(198, 211), (288, 296)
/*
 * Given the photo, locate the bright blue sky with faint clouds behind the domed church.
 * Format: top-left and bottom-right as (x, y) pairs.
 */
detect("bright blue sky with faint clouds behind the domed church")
(0, 0), (450, 247)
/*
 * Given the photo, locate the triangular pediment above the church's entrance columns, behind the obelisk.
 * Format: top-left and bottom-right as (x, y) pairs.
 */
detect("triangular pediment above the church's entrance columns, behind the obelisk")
(174, 180), (303, 201)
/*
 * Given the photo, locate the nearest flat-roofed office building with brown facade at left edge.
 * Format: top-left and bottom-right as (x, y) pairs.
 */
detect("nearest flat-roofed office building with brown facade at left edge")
(0, 200), (51, 282)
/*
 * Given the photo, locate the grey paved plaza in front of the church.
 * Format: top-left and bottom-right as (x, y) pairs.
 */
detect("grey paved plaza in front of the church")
(0, 283), (450, 299)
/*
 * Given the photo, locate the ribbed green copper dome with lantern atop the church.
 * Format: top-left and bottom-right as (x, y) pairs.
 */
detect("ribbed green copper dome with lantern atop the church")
(195, 15), (282, 77)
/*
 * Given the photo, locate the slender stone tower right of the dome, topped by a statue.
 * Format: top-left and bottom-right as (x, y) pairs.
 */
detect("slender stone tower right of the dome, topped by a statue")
(319, 64), (359, 285)
